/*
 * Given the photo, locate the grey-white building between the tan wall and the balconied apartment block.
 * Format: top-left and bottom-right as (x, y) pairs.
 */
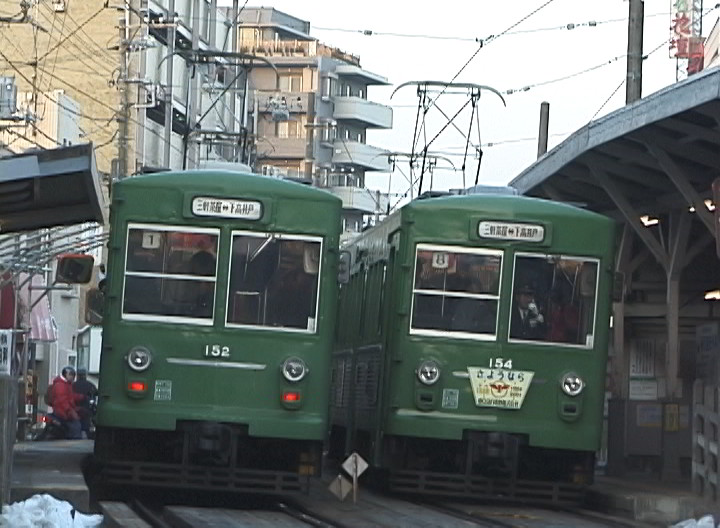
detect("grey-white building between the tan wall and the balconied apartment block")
(135, 0), (249, 171)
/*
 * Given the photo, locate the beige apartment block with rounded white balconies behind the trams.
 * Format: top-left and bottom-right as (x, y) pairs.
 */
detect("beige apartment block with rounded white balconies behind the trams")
(233, 7), (393, 232)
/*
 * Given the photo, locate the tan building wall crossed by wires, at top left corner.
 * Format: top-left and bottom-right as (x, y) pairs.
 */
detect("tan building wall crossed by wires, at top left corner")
(0, 0), (121, 174)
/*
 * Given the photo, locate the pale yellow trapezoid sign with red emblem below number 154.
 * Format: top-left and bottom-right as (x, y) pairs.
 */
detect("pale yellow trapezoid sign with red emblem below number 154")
(468, 367), (535, 409)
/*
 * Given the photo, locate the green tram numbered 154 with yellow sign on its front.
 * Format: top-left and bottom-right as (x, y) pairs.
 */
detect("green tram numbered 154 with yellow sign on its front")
(330, 194), (615, 501)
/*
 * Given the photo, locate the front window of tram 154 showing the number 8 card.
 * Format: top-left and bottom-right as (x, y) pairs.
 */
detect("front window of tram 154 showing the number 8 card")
(411, 245), (502, 337)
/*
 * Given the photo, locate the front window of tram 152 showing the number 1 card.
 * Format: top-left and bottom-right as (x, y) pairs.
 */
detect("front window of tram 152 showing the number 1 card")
(123, 226), (219, 320)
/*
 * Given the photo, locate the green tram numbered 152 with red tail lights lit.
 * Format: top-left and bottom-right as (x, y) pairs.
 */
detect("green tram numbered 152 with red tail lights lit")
(95, 171), (341, 493)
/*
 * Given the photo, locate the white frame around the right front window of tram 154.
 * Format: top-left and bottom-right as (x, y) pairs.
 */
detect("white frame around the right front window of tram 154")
(507, 252), (600, 350)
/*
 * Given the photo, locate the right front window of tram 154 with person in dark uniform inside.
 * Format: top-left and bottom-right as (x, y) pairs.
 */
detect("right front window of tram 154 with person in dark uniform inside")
(510, 254), (599, 347)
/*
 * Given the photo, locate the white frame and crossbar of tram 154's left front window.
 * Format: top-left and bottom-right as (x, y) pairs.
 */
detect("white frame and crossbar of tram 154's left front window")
(409, 243), (505, 341)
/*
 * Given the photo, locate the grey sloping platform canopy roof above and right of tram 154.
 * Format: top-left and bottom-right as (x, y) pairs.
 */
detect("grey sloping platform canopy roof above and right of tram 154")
(510, 68), (720, 221)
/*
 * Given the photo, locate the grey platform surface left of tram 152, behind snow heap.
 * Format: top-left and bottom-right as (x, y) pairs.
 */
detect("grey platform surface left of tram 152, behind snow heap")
(10, 440), (93, 512)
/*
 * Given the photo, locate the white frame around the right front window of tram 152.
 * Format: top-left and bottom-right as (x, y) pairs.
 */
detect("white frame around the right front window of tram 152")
(225, 230), (325, 334)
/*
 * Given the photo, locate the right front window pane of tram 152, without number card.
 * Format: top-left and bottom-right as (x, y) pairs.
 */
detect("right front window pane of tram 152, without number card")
(227, 233), (321, 332)
